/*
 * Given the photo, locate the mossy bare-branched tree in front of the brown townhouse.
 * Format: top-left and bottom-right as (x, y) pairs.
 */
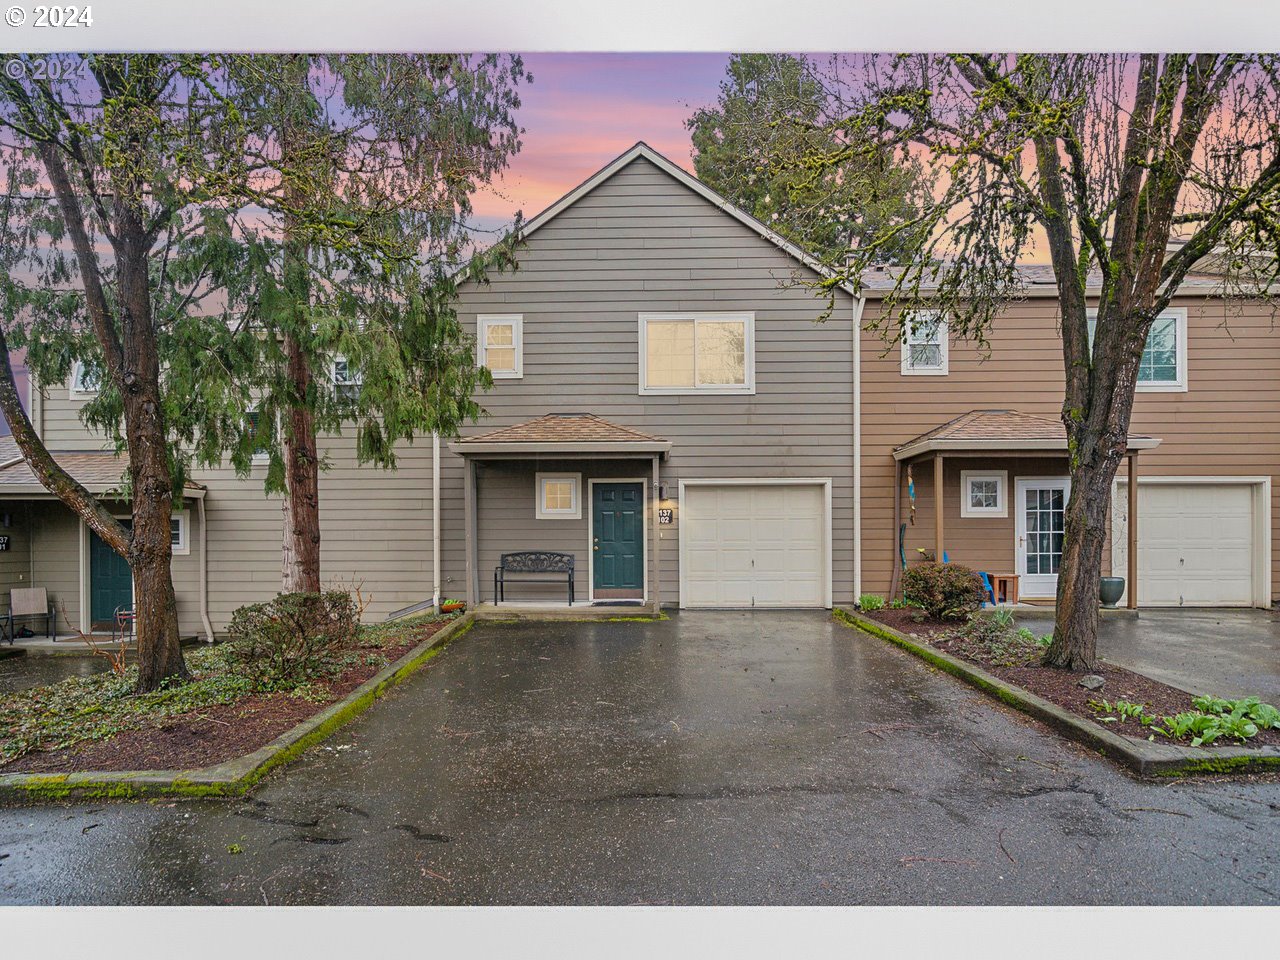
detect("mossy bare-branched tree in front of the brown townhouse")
(780, 54), (1280, 669)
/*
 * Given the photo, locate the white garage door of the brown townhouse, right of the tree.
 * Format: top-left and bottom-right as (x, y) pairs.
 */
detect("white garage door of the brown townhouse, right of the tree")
(1114, 479), (1254, 607)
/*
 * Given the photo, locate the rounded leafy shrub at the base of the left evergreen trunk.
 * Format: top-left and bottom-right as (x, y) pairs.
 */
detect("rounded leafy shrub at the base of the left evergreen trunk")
(227, 590), (360, 690)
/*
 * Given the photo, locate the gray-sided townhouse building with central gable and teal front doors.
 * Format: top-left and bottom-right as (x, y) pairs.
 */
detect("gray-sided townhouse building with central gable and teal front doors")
(0, 143), (858, 636)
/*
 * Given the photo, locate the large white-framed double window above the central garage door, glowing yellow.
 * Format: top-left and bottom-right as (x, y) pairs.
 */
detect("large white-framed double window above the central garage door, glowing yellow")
(640, 314), (755, 394)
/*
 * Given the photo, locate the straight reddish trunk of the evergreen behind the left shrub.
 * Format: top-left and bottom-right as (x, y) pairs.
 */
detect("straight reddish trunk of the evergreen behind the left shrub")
(280, 337), (320, 593)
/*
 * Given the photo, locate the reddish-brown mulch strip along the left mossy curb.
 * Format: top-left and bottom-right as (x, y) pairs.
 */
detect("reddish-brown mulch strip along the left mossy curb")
(0, 621), (452, 773)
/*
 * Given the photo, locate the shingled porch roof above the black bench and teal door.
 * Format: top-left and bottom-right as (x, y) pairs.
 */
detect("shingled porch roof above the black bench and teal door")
(449, 413), (671, 457)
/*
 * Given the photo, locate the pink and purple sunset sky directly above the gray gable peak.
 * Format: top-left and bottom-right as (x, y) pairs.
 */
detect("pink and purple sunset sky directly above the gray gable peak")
(475, 54), (730, 229)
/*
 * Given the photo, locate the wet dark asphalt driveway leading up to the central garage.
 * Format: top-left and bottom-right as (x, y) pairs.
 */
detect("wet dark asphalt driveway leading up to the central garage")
(0, 612), (1280, 904)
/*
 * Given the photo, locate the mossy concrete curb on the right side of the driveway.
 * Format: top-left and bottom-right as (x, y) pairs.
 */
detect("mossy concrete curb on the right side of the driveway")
(832, 607), (1280, 777)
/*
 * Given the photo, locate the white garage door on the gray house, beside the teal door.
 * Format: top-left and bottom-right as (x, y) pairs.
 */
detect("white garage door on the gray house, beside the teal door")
(680, 483), (829, 607)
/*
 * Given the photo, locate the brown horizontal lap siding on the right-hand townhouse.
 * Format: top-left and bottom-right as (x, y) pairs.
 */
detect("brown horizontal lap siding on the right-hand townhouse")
(863, 297), (1280, 604)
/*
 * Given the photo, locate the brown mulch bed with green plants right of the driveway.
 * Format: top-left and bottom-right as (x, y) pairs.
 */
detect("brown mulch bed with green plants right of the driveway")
(863, 609), (1280, 749)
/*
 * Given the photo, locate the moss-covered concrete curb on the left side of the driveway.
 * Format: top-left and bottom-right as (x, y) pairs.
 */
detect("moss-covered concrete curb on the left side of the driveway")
(0, 614), (475, 801)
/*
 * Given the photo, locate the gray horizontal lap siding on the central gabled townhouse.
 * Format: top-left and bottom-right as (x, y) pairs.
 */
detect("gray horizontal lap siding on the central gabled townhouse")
(442, 160), (852, 603)
